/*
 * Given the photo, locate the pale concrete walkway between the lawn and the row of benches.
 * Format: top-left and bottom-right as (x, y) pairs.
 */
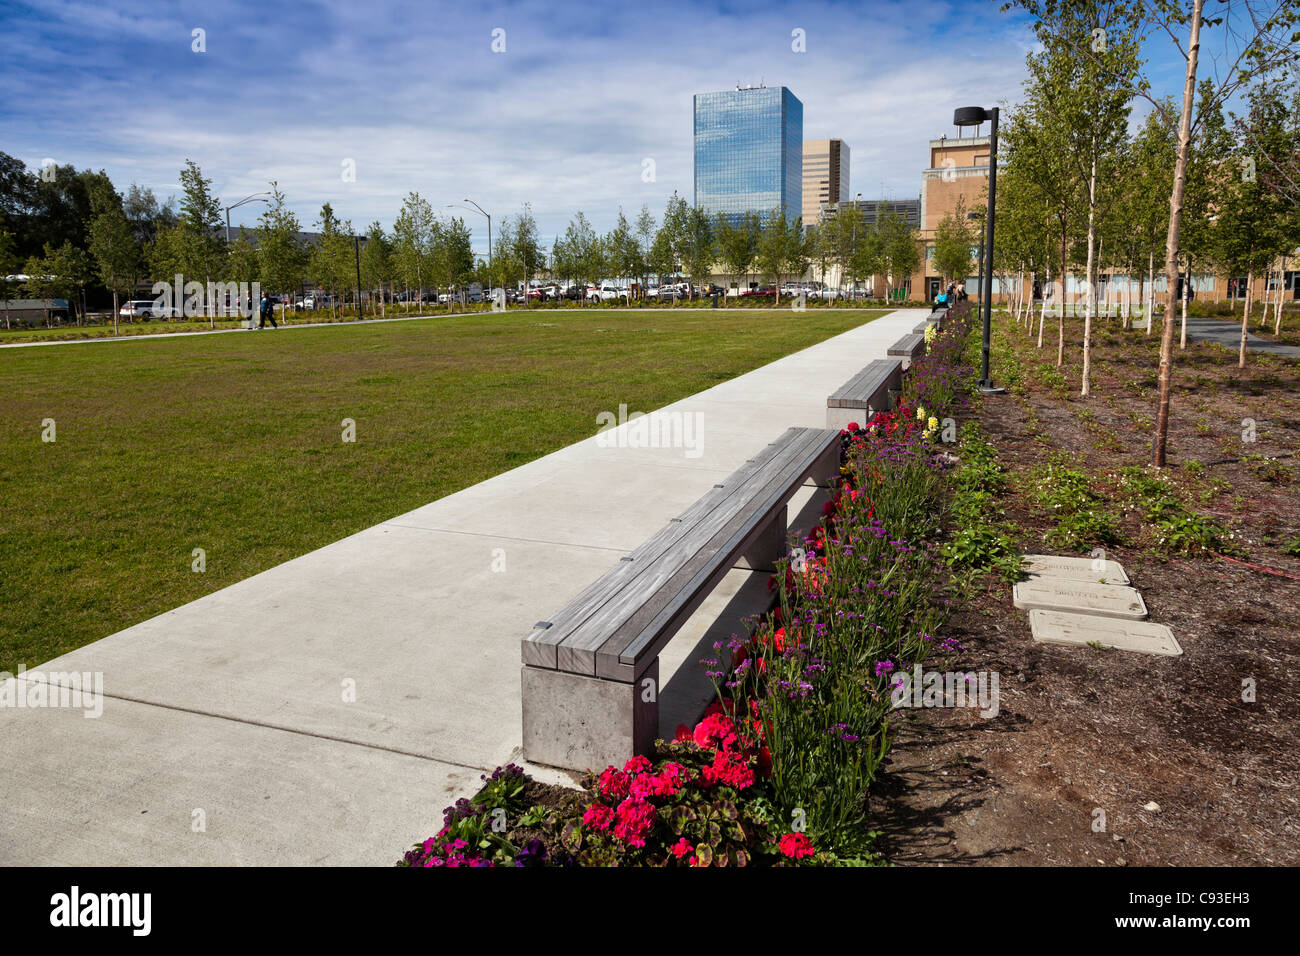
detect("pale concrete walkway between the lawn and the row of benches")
(0, 310), (926, 865)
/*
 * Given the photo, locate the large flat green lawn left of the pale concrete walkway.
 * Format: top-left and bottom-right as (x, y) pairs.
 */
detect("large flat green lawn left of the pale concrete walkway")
(0, 310), (883, 671)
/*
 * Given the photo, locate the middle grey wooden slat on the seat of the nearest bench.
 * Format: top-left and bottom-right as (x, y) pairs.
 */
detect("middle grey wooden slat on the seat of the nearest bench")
(556, 429), (822, 674)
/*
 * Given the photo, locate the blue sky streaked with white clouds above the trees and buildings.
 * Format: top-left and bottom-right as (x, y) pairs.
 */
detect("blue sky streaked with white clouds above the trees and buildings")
(0, 0), (1248, 250)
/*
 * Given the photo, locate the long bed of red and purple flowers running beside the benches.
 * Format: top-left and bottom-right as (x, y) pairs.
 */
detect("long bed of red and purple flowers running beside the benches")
(402, 319), (971, 866)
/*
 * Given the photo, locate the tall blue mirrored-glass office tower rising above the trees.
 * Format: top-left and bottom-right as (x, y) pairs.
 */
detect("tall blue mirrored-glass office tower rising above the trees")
(696, 86), (803, 222)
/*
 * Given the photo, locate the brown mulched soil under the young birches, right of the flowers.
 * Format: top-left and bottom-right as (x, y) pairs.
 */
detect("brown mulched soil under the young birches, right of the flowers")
(874, 314), (1300, 866)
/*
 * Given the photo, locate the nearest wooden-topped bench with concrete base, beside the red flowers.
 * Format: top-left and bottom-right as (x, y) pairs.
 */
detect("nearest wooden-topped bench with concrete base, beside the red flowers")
(521, 428), (840, 770)
